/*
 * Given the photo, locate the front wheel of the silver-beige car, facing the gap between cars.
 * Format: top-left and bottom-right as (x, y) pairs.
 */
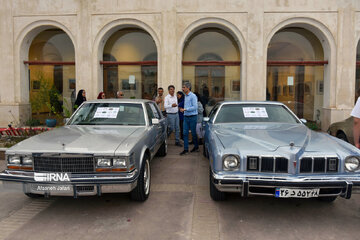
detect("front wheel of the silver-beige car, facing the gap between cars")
(130, 155), (151, 202)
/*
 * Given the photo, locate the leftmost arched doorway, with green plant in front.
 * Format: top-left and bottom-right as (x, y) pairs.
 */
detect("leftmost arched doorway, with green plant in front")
(24, 28), (76, 120)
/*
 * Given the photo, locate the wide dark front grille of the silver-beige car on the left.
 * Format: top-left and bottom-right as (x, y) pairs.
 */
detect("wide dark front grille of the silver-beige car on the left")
(34, 155), (95, 173)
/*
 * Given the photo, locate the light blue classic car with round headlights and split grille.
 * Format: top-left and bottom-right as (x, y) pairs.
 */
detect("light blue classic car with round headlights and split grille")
(204, 102), (360, 202)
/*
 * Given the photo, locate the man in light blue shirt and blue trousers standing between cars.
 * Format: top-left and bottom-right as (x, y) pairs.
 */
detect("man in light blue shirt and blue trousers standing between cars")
(180, 82), (199, 155)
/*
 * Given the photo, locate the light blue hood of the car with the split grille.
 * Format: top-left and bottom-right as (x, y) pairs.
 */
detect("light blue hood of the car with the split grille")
(214, 123), (352, 153)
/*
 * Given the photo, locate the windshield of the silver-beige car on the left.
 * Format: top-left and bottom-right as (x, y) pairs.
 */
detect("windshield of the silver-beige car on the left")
(69, 103), (145, 126)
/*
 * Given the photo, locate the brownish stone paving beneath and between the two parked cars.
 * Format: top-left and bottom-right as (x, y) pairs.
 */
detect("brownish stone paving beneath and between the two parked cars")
(0, 141), (360, 240)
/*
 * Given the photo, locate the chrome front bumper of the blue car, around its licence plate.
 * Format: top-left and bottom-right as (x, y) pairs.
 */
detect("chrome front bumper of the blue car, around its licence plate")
(211, 172), (360, 199)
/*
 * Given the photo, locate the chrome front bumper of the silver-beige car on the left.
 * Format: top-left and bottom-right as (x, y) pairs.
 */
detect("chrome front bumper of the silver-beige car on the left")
(0, 170), (138, 197)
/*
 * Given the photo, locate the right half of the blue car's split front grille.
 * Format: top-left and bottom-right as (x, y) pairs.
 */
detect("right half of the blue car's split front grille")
(300, 157), (339, 173)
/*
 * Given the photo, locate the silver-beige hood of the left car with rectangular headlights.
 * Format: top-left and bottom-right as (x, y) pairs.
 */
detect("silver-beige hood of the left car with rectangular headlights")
(6, 126), (145, 155)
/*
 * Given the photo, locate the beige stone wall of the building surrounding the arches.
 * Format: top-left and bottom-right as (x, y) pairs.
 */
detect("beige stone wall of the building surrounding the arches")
(0, 0), (360, 129)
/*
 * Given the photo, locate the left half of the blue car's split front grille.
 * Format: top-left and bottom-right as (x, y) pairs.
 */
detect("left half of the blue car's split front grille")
(247, 156), (289, 173)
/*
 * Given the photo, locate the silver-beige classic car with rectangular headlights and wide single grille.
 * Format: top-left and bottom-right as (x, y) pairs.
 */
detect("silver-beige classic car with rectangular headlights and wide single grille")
(0, 99), (167, 201)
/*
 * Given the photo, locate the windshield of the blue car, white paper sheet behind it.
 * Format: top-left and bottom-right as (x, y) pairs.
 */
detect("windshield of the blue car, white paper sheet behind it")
(215, 104), (299, 123)
